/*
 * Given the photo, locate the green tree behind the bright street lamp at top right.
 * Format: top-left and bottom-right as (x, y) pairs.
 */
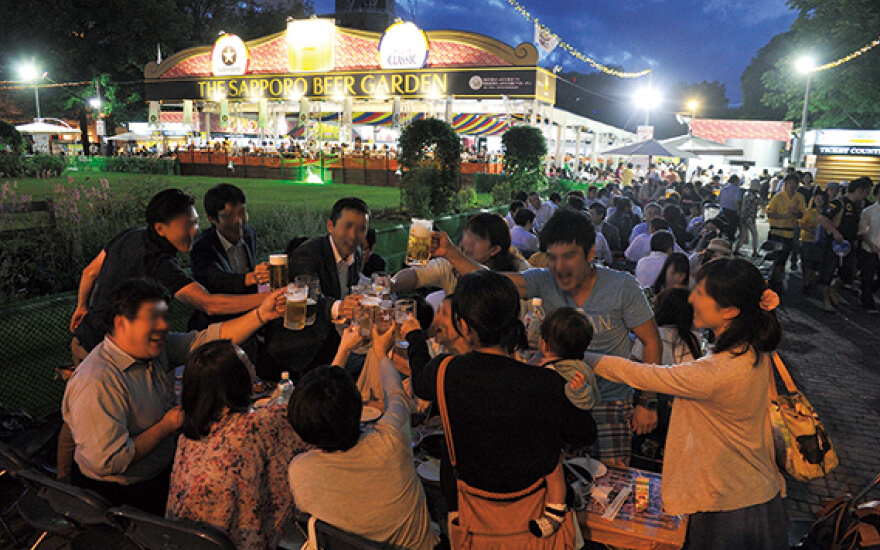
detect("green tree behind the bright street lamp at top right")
(748, 0), (880, 128)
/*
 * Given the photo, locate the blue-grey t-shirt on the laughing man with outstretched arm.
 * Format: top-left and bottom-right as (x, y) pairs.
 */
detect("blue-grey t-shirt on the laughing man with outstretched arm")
(522, 267), (654, 401)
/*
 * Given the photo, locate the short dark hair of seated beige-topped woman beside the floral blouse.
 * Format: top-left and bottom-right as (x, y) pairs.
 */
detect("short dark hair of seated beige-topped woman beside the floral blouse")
(287, 365), (363, 452)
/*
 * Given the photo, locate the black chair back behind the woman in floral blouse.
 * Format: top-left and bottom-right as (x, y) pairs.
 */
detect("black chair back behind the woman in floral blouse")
(108, 506), (235, 550)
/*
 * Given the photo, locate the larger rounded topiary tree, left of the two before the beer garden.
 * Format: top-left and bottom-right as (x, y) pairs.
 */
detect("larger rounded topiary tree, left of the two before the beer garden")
(398, 118), (461, 218)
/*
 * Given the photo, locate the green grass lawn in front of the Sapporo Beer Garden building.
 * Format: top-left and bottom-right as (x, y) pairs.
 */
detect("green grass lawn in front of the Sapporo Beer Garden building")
(6, 172), (400, 227)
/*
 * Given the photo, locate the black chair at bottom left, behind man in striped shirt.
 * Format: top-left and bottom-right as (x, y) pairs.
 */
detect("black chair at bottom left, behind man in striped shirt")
(17, 469), (135, 550)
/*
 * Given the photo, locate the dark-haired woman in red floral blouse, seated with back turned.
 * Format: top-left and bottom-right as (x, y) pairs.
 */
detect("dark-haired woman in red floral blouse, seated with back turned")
(167, 341), (309, 550)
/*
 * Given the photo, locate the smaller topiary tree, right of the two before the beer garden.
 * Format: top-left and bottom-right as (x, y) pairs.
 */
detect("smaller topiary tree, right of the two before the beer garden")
(492, 126), (547, 202)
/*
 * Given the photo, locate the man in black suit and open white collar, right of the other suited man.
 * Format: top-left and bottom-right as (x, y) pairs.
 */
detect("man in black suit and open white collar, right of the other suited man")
(257, 197), (370, 382)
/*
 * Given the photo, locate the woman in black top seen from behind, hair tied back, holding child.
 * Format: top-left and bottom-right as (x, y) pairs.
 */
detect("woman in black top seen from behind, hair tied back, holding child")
(406, 271), (596, 548)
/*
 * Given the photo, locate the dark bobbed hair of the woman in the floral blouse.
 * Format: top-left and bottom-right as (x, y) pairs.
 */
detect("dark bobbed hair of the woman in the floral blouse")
(180, 340), (253, 440)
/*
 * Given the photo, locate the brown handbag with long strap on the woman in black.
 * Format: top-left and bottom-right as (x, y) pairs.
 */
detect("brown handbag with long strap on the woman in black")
(437, 356), (575, 550)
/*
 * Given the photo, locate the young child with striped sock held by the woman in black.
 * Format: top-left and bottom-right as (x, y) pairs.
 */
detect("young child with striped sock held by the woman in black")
(529, 307), (599, 538)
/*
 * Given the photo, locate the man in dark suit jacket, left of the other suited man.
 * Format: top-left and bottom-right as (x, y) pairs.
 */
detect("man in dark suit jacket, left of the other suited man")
(189, 183), (269, 330)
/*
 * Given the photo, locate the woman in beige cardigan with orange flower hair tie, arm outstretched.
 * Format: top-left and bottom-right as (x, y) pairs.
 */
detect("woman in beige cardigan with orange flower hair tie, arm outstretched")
(587, 258), (788, 550)
